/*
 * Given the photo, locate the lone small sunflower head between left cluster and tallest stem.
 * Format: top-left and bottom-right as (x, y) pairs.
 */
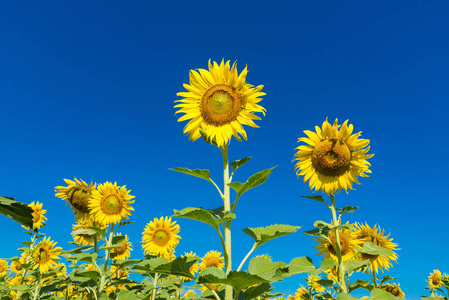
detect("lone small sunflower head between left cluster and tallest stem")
(142, 217), (181, 260)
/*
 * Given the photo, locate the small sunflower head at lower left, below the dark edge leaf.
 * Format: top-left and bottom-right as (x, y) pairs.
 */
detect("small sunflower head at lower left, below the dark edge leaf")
(31, 237), (62, 274)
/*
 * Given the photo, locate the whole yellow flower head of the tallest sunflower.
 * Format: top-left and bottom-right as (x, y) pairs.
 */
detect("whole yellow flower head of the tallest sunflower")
(175, 59), (266, 147)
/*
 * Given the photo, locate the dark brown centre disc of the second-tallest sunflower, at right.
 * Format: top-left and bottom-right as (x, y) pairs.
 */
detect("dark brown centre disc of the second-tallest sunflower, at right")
(312, 139), (351, 176)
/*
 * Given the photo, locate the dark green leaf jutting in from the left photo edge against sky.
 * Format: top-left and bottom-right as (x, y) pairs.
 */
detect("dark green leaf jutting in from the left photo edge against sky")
(0, 197), (33, 228)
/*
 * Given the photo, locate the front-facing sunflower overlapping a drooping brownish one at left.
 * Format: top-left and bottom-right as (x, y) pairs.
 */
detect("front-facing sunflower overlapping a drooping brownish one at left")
(89, 181), (135, 226)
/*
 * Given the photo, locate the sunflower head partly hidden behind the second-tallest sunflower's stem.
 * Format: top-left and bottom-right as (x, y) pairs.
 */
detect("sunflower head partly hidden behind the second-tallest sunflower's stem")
(314, 228), (362, 261)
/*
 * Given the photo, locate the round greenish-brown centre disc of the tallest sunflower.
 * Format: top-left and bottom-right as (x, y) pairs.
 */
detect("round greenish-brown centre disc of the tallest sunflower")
(200, 84), (243, 126)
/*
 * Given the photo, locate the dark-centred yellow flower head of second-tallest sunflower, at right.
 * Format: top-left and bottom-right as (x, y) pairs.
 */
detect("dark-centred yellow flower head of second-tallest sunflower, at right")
(293, 118), (374, 195)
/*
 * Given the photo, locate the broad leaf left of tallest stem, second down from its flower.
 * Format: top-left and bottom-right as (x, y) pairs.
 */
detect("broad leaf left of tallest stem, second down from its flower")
(173, 207), (235, 231)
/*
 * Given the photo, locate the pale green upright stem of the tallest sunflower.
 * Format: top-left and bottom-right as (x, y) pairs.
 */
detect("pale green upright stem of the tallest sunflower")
(221, 144), (232, 300)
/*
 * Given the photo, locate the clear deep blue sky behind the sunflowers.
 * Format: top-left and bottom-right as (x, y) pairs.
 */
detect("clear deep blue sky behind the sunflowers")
(0, 1), (449, 299)
